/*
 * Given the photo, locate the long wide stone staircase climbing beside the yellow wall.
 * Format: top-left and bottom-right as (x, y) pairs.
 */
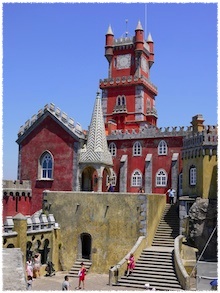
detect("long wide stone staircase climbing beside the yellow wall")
(113, 204), (182, 291)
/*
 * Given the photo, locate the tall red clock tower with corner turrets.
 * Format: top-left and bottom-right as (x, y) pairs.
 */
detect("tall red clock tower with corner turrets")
(100, 21), (157, 131)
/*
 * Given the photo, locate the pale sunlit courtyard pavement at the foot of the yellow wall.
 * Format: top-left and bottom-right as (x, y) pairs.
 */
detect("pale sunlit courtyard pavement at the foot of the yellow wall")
(32, 271), (143, 292)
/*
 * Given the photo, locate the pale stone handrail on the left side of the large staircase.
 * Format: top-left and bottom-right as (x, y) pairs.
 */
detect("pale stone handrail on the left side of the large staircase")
(109, 236), (146, 286)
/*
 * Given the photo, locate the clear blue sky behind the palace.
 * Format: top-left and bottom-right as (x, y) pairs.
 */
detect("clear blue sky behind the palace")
(2, 3), (217, 180)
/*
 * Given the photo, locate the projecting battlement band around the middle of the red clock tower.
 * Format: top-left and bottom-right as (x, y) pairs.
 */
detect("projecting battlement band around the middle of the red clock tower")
(99, 75), (157, 94)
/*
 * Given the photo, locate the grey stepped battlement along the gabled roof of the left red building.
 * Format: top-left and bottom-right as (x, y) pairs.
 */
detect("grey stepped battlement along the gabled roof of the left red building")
(18, 103), (84, 137)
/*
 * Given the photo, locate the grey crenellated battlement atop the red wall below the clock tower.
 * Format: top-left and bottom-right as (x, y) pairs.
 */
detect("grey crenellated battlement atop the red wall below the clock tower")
(108, 124), (192, 140)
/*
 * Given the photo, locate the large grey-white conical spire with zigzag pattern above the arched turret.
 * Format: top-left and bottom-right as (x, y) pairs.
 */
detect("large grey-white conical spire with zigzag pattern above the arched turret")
(79, 92), (113, 166)
